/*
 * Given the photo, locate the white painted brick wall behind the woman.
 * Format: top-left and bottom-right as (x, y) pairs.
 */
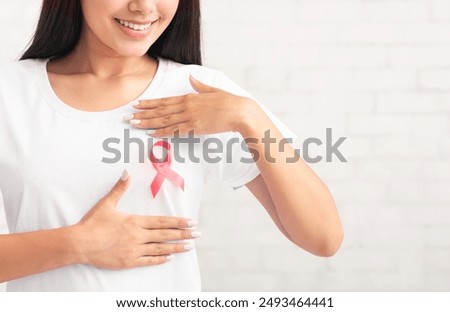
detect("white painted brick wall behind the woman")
(0, 0), (450, 291)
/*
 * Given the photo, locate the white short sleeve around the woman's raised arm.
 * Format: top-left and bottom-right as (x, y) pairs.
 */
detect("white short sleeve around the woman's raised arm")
(203, 72), (297, 189)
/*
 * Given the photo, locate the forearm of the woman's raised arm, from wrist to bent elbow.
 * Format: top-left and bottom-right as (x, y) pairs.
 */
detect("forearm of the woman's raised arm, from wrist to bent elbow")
(240, 100), (343, 256)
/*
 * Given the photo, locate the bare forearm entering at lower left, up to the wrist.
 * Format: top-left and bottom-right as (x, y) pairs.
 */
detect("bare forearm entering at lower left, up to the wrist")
(0, 226), (78, 282)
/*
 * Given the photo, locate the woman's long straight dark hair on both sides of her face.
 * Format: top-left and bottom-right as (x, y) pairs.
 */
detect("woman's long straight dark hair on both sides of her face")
(20, 0), (202, 65)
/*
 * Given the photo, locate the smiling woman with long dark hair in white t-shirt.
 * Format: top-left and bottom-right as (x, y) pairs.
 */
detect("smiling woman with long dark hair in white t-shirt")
(0, 0), (343, 291)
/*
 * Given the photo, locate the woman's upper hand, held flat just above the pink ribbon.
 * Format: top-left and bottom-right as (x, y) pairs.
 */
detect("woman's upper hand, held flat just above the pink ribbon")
(126, 76), (258, 137)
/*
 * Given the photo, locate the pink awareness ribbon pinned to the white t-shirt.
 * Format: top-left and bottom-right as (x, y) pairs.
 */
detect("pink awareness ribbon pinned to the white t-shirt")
(149, 141), (184, 198)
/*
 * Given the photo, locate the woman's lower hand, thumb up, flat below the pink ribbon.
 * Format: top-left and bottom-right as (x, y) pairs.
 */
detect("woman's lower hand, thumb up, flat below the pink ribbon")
(74, 171), (201, 269)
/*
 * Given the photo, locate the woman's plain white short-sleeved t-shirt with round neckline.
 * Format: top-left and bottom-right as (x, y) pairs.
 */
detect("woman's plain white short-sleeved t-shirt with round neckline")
(0, 59), (295, 291)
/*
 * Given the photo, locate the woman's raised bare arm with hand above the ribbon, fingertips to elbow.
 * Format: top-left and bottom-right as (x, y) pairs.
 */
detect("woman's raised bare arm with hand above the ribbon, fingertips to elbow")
(130, 76), (344, 257)
